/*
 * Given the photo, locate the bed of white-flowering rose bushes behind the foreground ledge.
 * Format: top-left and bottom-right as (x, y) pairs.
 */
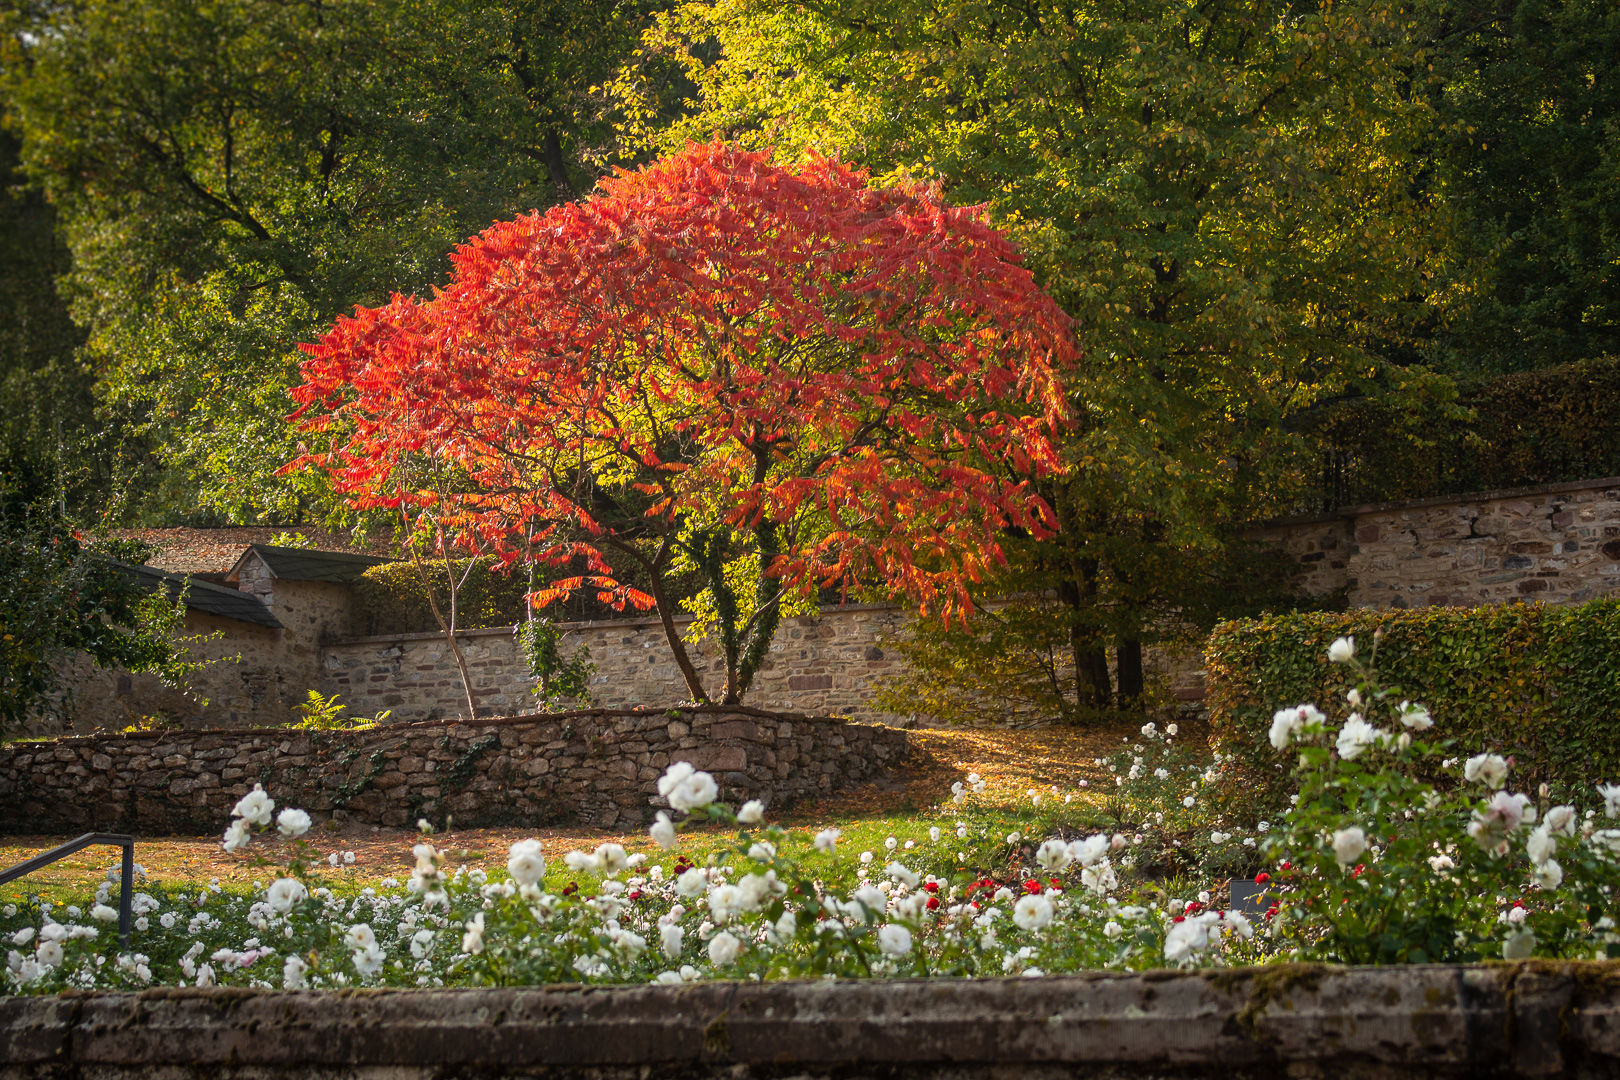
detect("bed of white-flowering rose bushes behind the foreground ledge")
(0, 640), (1620, 993)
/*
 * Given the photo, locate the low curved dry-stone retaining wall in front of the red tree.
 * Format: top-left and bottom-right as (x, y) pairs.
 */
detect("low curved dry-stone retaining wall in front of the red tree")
(0, 708), (909, 836)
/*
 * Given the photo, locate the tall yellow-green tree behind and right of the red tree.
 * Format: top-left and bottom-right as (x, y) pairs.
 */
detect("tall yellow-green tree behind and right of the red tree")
(645, 0), (1443, 704)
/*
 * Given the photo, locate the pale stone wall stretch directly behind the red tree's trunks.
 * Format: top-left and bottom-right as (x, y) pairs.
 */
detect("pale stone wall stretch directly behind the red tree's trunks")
(322, 604), (907, 722)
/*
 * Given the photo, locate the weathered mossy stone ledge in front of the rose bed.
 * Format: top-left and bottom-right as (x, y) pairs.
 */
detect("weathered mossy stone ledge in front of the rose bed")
(0, 963), (1620, 1080)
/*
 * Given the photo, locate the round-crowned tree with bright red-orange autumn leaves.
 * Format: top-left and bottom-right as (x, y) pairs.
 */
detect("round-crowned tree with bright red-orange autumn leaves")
(293, 142), (1074, 703)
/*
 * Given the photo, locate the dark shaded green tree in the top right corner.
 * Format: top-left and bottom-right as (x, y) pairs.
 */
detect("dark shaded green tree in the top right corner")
(1426, 0), (1620, 374)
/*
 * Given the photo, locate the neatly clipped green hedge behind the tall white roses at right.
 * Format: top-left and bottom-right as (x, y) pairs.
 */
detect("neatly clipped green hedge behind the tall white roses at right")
(1205, 599), (1620, 805)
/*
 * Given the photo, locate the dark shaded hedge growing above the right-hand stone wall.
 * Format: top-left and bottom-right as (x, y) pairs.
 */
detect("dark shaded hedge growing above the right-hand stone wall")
(1309, 356), (1620, 510)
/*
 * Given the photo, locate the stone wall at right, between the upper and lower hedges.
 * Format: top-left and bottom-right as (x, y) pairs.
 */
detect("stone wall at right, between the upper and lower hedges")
(1251, 476), (1620, 607)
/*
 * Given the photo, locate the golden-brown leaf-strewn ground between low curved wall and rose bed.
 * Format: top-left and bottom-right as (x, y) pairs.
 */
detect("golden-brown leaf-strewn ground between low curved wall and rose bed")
(0, 727), (1166, 895)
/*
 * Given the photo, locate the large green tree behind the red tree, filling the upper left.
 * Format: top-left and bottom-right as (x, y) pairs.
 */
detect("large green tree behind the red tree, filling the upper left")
(0, 0), (683, 518)
